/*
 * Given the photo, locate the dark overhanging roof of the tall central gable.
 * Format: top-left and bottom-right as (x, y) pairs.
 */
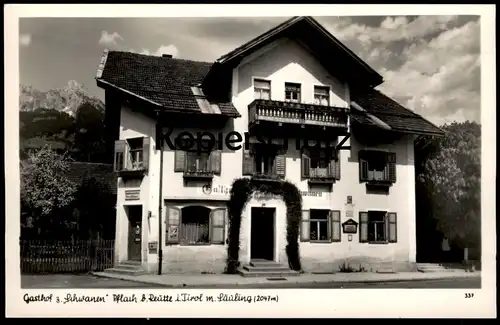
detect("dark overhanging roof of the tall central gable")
(216, 16), (383, 87)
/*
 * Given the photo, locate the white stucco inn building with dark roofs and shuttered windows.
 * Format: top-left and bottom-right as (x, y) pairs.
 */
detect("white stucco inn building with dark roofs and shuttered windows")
(96, 17), (442, 273)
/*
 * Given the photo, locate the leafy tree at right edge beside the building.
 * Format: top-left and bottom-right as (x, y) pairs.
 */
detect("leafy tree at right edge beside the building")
(417, 121), (481, 259)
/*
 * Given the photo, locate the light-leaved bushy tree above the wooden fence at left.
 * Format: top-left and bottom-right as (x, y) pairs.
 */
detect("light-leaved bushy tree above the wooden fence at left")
(21, 146), (77, 232)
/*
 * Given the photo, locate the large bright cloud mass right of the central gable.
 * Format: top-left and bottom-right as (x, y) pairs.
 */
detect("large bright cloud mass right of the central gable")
(380, 21), (481, 124)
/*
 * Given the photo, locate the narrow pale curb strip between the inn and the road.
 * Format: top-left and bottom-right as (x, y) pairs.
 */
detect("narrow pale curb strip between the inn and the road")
(92, 272), (481, 289)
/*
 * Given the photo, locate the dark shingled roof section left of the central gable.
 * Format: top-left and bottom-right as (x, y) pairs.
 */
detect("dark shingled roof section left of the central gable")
(96, 51), (240, 117)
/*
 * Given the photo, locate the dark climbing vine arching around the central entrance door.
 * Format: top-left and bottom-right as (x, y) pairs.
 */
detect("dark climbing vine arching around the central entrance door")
(226, 178), (302, 274)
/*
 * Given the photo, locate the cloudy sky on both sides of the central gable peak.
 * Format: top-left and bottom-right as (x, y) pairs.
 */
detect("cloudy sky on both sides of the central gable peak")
(19, 16), (480, 125)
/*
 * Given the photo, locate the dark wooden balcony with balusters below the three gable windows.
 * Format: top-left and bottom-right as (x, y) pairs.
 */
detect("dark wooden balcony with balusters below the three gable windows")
(248, 99), (348, 130)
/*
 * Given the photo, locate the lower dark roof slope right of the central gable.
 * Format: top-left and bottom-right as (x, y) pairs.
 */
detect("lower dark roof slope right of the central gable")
(351, 89), (444, 135)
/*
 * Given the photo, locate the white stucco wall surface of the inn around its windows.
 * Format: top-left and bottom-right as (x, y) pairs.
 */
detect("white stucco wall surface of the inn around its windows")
(117, 39), (416, 271)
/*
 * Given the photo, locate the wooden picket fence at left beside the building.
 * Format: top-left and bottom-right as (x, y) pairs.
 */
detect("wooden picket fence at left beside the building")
(20, 240), (115, 274)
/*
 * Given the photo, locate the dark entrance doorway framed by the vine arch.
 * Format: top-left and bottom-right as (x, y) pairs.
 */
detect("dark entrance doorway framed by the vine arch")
(250, 208), (275, 261)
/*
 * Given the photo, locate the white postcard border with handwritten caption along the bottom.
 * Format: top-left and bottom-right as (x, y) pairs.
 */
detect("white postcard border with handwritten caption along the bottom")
(4, 4), (496, 318)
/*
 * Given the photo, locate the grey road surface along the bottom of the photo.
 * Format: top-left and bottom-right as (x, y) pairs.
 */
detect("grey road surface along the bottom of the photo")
(21, 274), (481, 289)
